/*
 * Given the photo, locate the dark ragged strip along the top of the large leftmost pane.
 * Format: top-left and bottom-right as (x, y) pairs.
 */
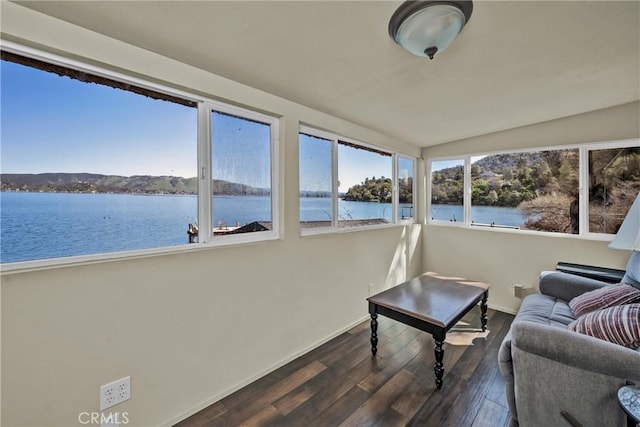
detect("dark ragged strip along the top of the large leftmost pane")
(0, 51), (198, 107)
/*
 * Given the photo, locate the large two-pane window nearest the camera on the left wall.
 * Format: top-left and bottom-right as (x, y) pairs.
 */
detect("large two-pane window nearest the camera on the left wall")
(0, 45), (278, 264)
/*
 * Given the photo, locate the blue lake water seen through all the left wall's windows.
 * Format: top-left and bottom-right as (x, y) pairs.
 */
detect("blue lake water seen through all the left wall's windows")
(0, 192), (416, 262)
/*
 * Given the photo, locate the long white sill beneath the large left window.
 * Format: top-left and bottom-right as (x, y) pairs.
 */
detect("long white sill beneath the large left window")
(0, 231), (280, 276)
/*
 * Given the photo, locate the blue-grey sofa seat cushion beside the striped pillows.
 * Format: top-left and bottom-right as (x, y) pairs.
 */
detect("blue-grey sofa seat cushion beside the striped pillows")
(514, 294), (576, 329)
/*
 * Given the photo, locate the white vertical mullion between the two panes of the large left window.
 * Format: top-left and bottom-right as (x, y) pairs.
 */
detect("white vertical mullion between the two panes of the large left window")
(198, 102), (213, 243)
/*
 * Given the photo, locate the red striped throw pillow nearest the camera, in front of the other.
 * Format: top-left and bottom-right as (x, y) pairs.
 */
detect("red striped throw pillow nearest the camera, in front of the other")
(567, 304), (640, 349)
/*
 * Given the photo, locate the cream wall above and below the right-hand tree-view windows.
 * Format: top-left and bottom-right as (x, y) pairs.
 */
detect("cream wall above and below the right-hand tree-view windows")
(423, 102), (640, 312)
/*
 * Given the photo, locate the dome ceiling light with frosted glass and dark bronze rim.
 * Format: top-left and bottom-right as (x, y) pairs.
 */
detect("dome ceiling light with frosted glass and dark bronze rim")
(389, 1), (473, 59)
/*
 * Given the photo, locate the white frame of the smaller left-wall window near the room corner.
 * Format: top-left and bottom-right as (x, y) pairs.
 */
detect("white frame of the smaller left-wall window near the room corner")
(298, 123), (417, 236)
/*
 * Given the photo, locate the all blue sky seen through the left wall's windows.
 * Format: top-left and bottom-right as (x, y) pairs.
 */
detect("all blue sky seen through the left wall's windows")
(0, 61), (400, 191)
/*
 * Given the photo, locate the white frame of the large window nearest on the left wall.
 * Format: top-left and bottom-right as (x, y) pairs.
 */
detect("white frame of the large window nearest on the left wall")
(0, 40), (282, 273)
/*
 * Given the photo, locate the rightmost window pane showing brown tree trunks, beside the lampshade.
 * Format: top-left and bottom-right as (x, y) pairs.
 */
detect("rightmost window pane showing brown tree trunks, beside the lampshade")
(589, 147), (640, 234)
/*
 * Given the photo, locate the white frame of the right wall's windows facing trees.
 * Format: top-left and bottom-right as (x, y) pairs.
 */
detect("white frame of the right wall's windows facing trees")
(425, 138), (640, 241)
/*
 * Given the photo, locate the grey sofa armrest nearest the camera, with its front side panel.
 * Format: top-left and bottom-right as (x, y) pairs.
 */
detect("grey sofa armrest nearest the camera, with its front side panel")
(511, 321), (640, 427)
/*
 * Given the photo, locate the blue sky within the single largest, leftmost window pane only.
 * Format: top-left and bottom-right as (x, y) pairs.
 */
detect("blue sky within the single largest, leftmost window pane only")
(0, 61), (197, 177)
